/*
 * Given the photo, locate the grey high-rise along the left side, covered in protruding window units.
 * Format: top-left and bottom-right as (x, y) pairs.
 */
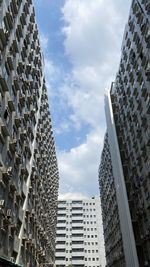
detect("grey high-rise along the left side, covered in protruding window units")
(0, 0), (59, 267)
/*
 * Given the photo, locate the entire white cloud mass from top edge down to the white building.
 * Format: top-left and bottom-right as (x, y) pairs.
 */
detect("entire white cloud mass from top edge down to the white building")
(58, 0), (130, 198)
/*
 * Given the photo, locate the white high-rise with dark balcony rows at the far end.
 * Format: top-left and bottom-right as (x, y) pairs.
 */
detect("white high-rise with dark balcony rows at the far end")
(55, 197), (105, 267)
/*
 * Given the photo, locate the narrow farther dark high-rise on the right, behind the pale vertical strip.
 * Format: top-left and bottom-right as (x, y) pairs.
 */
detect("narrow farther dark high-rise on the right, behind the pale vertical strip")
(99, 134), (126, 267)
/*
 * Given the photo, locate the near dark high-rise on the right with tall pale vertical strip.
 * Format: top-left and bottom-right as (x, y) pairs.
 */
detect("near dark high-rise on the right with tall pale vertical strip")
(99, 0), (150, 267)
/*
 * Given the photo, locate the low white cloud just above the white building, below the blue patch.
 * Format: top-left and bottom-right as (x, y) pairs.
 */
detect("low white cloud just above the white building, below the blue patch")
(58, 128), (104, 195)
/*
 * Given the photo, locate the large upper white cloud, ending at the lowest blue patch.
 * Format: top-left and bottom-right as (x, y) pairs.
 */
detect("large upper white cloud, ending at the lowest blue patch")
(62, 0), (129, 127)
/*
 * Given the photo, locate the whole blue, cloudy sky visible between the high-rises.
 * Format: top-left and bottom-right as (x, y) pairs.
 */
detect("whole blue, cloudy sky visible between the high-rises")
(34, 0), (131, 198)
